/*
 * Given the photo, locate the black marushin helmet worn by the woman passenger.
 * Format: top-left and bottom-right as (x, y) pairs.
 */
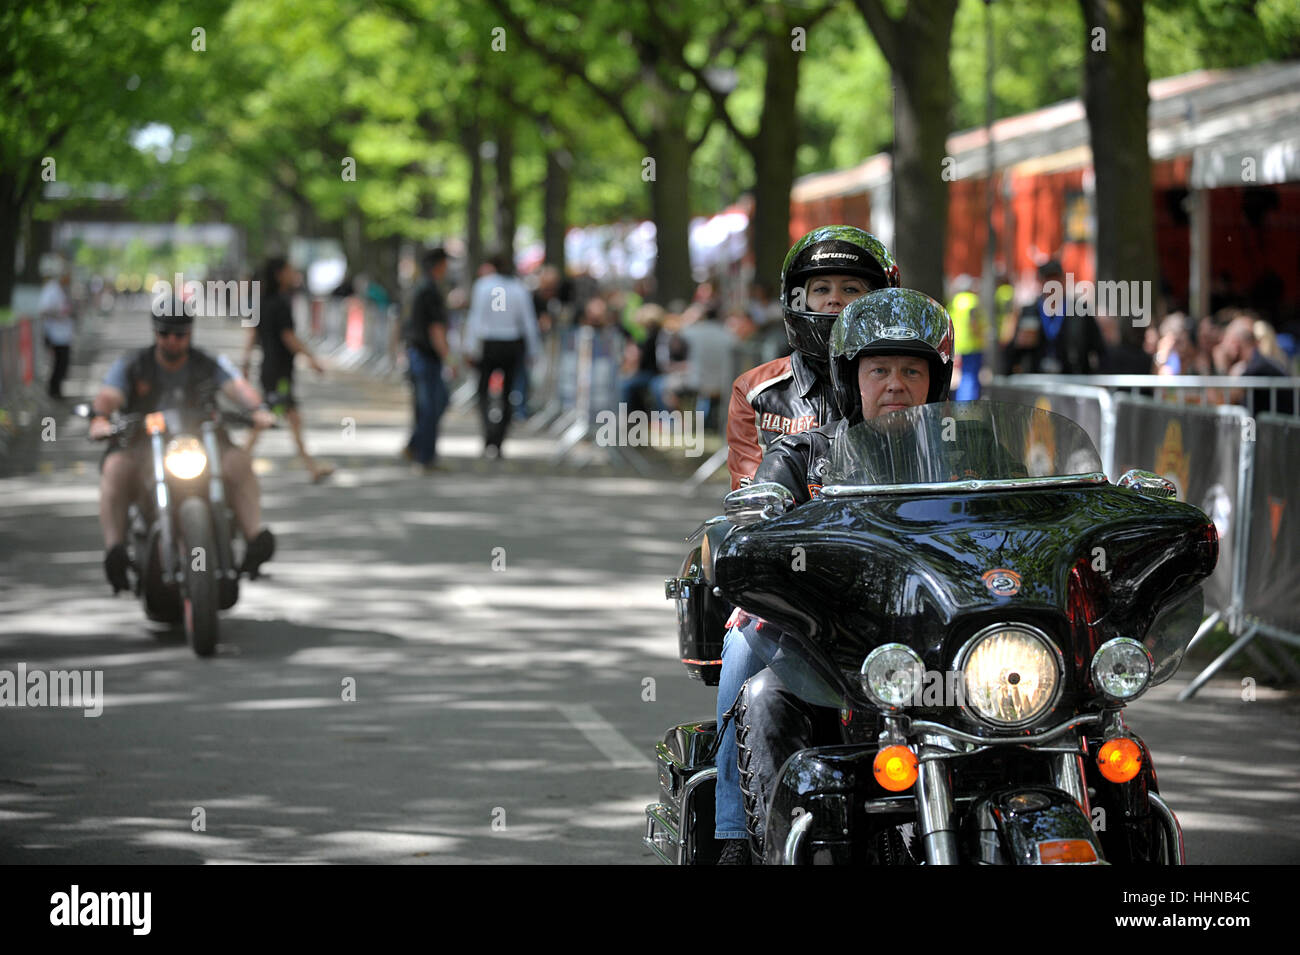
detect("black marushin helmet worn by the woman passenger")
(780, 226), (898, 366)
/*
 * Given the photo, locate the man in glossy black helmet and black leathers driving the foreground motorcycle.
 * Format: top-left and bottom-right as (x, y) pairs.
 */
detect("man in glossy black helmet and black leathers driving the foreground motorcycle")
(737, 288), (954, 857)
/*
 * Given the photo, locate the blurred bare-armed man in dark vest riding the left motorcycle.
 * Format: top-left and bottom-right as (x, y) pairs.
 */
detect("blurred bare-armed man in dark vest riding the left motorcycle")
(90, 314), (276, 594)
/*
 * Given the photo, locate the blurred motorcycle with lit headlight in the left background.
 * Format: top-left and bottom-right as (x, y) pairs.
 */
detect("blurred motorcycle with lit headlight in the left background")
(77, 405), (252, 656)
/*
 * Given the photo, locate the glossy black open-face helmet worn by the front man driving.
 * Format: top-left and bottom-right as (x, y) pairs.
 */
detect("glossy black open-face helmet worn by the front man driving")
(829, 288), (954, 421)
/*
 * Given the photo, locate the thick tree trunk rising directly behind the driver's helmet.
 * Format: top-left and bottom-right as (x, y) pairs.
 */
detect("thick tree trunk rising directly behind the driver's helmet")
(893, 0), (957, 300)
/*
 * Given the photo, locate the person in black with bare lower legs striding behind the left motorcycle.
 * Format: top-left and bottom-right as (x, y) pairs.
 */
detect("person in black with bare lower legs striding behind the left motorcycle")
(241, 256), (334, 483)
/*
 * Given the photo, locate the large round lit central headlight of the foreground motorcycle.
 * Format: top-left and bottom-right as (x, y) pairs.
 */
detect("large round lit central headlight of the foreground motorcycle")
(957, 624), (1065, 726)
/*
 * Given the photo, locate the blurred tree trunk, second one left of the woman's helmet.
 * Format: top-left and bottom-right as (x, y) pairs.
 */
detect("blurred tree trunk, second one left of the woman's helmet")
(642, 121), (696, 304)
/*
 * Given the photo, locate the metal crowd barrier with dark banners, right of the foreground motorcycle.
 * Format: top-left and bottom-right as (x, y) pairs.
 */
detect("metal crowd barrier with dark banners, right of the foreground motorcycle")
(988, 376), (1300, 700)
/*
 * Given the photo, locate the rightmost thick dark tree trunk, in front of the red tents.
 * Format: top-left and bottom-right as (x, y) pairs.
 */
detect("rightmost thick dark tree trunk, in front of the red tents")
(1080, 0), (1160, 343)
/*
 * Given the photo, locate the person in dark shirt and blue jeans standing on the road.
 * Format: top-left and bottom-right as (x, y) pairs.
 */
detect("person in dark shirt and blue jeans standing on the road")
(404, 247), (449, 473)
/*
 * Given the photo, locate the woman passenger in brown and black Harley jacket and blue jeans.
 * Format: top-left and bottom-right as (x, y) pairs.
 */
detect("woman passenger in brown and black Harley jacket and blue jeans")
(714, 225), (898, 864)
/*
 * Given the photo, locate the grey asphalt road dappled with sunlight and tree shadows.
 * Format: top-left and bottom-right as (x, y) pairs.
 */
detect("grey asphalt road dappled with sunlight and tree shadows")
(0, 310), (1300, 863)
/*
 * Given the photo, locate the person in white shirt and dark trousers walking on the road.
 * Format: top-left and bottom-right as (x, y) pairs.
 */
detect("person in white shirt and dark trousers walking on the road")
(462, 255), (541, 457)
